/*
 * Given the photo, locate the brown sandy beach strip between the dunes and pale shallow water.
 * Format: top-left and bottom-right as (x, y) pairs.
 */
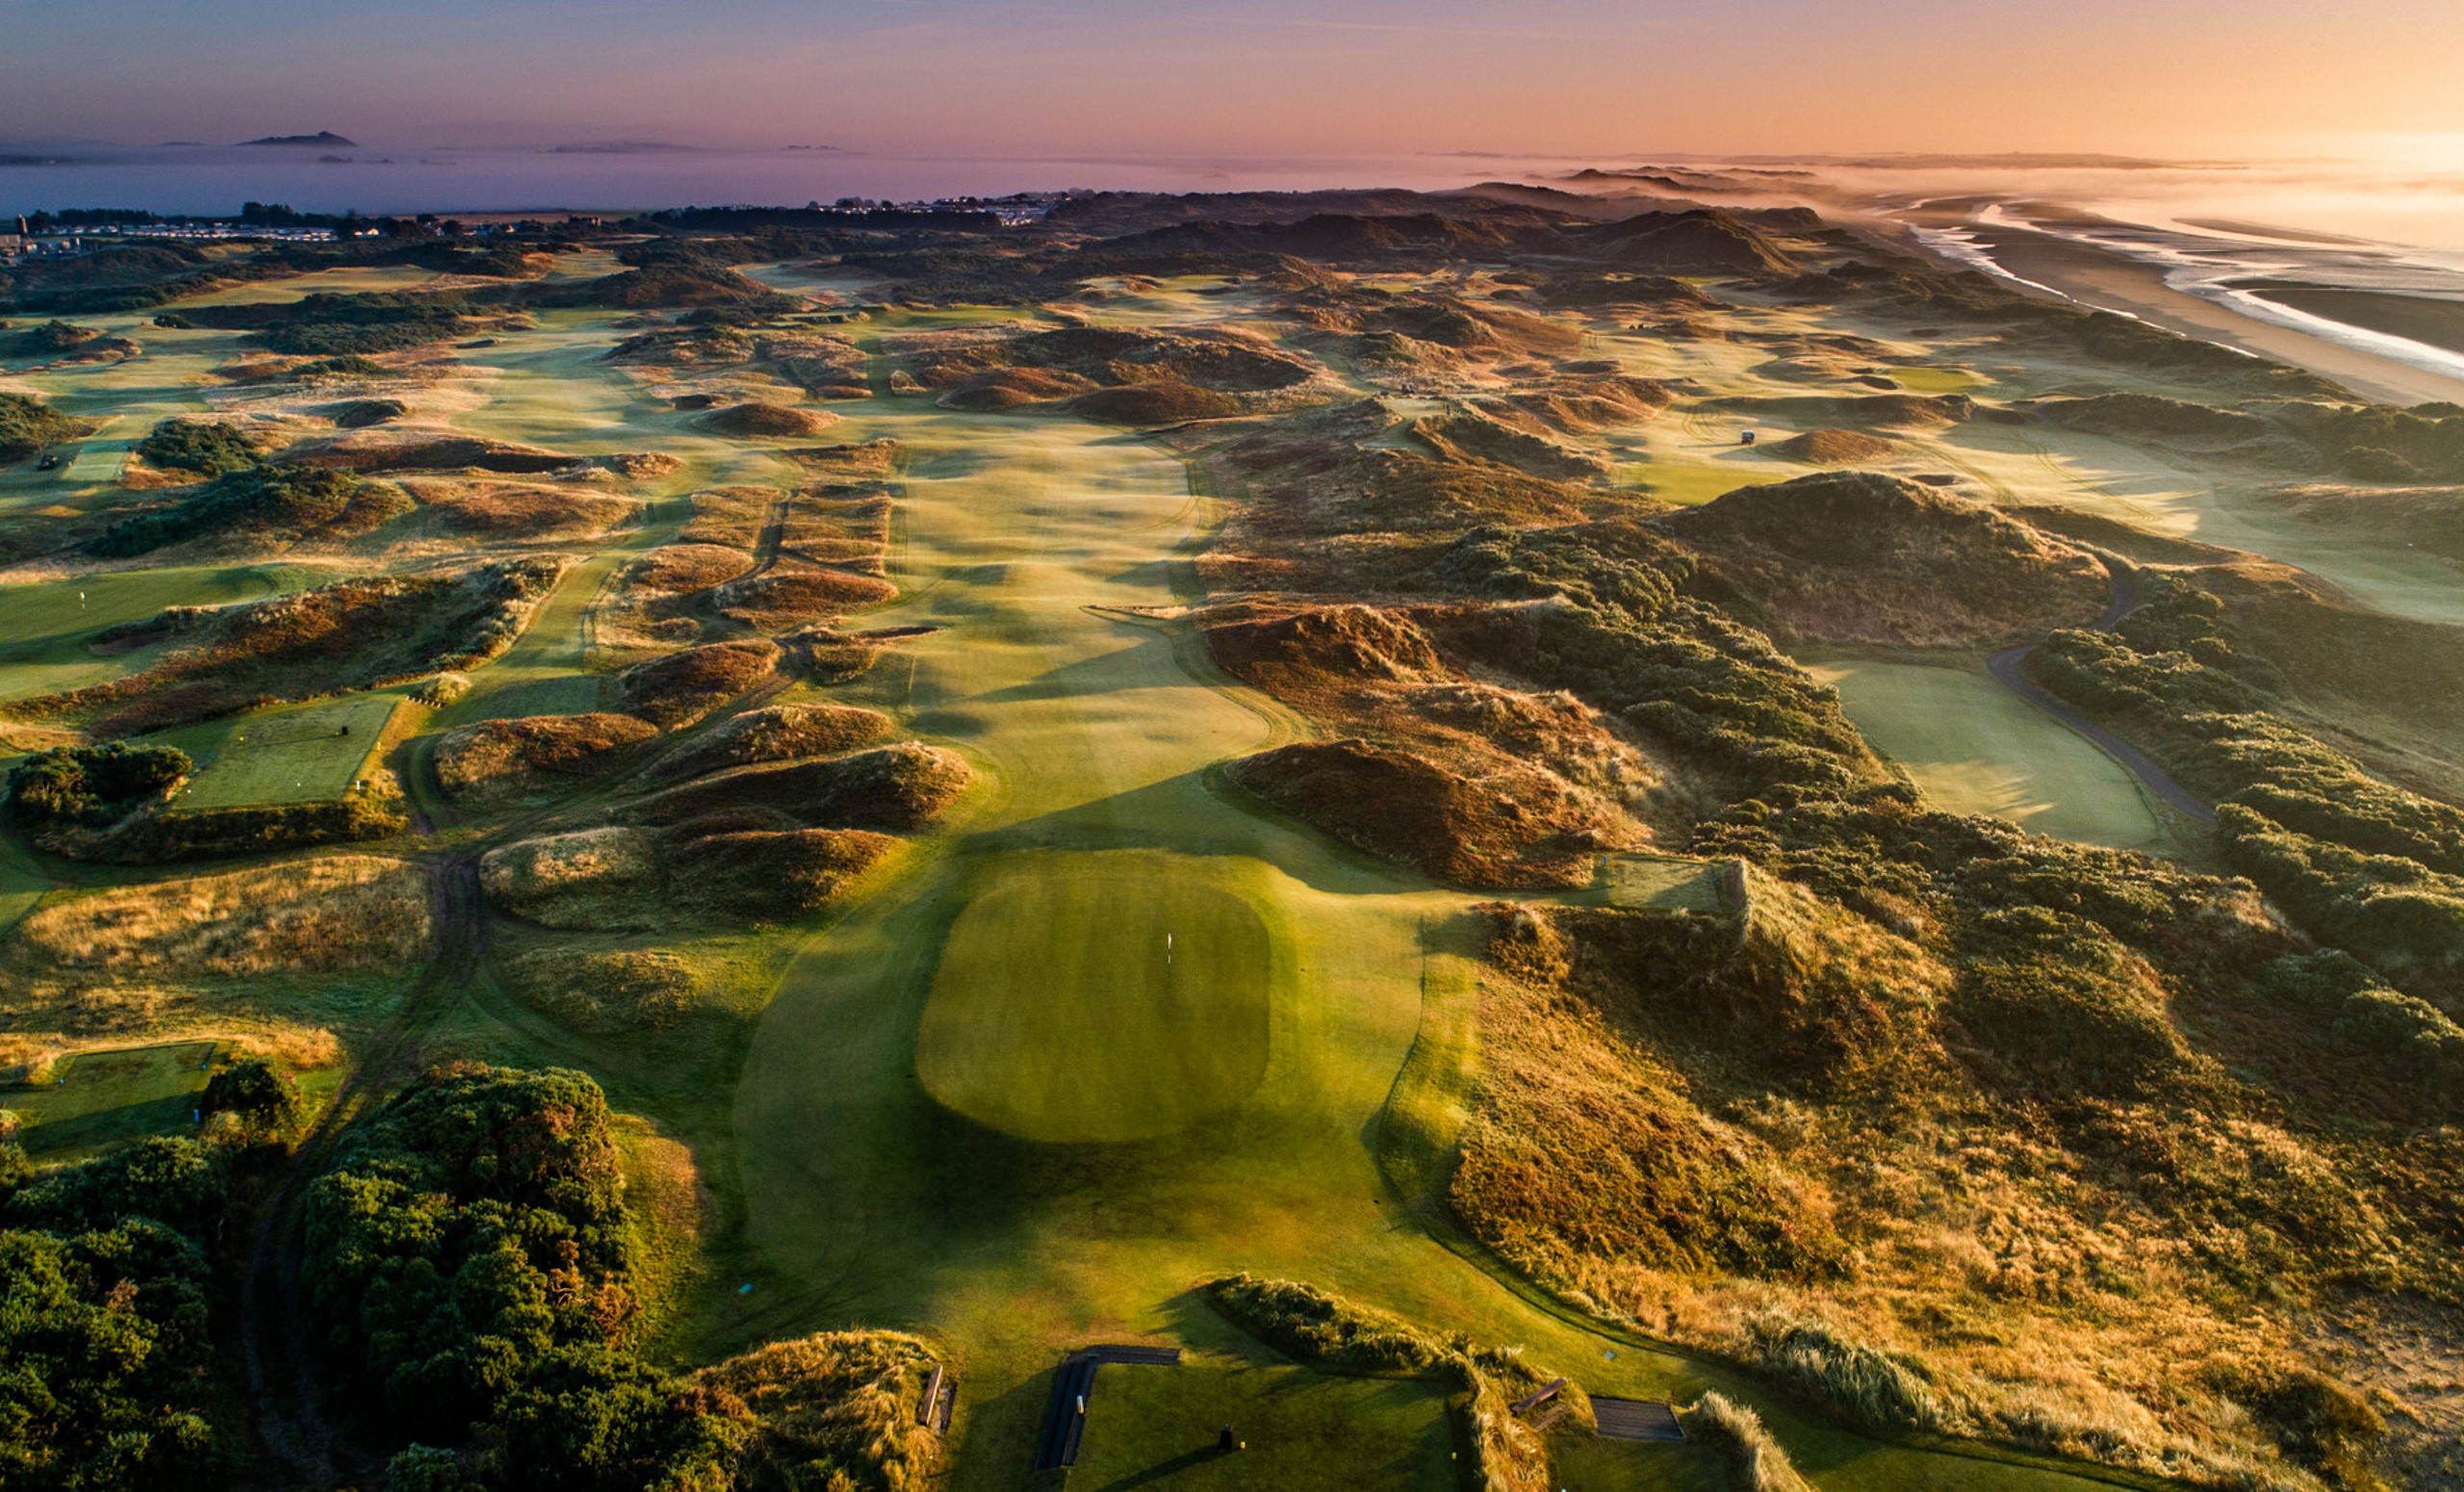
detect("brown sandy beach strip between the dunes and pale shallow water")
(1961, 224), (2464, 404)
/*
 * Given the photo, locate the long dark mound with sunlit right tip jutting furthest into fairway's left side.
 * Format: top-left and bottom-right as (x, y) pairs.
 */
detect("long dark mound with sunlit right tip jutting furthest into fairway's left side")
(633, 742), (973, 831)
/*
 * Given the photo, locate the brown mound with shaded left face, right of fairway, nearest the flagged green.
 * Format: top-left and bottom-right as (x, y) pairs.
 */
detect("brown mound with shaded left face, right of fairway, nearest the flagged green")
(1224, 740), (1604, 886)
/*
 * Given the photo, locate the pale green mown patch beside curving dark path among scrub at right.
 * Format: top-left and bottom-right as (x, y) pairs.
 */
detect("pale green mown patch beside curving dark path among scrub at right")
(1806, 661), (2159, 848)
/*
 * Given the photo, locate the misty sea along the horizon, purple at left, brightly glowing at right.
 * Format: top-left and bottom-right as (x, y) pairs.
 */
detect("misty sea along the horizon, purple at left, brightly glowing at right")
(0, 138), (2464, 397)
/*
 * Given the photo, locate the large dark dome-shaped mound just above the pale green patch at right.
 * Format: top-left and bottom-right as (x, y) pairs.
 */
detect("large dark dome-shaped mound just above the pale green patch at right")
(1660, 471), (2109, 646)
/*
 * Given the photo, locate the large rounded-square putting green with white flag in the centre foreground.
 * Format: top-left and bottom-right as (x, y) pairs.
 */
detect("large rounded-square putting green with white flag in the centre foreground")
(916, 851), (1274, 1142)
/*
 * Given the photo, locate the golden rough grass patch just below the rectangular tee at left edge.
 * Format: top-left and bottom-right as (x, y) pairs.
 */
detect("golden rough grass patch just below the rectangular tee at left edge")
(13, 856), (431, 977)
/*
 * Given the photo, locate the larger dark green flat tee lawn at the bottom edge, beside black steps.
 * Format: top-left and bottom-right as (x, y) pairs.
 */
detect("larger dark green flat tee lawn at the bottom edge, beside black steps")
(1069, 1361), (1453, 1492)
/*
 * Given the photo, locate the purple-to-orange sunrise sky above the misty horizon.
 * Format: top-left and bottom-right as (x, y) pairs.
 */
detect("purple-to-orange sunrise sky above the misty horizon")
(0, 0), (2464, 167)
